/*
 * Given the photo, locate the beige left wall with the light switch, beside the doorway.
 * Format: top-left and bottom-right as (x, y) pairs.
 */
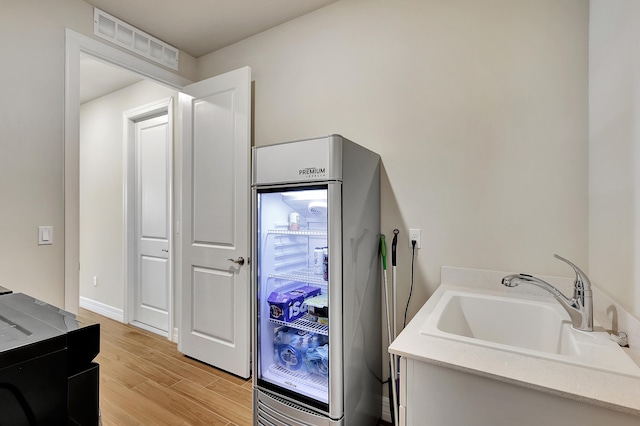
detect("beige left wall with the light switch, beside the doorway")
(0, 0), (195, 306)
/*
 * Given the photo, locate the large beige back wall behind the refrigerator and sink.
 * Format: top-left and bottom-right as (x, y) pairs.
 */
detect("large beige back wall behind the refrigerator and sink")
(198, 0), (589, 320)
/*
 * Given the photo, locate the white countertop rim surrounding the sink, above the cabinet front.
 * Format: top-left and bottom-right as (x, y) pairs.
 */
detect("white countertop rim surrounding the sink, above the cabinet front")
(389, 280), (640, 416)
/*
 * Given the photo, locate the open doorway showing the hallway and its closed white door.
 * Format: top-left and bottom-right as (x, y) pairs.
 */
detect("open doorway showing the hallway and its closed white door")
(79, 59), (177, 336)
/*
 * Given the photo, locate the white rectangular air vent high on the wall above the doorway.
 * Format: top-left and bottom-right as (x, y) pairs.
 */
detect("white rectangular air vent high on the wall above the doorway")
(93, 8), (180, 71)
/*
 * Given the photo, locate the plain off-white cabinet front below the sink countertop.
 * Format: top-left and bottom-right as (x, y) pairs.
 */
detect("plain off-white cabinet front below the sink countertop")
(399, 357), (640, 426)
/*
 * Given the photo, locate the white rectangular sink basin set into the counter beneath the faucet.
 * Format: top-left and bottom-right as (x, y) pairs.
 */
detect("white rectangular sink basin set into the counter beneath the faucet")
(420, 290), (640, 377)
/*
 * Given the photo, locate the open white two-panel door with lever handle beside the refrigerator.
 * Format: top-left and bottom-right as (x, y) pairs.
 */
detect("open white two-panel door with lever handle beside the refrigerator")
(178, 67), (251, 377)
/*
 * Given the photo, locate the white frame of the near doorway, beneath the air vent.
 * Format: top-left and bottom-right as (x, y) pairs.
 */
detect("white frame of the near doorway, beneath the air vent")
(63, 28), (192, 314)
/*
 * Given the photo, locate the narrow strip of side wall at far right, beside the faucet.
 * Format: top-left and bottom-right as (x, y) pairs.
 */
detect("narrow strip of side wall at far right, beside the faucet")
(589, 0), (640, 316)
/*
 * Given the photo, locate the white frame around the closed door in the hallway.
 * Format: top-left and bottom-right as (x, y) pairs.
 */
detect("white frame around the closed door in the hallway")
(122, 97), (174, 334)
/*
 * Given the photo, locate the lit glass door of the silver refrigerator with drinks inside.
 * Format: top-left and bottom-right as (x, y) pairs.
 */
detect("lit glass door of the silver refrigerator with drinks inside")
(256, 185), (329, 410)
